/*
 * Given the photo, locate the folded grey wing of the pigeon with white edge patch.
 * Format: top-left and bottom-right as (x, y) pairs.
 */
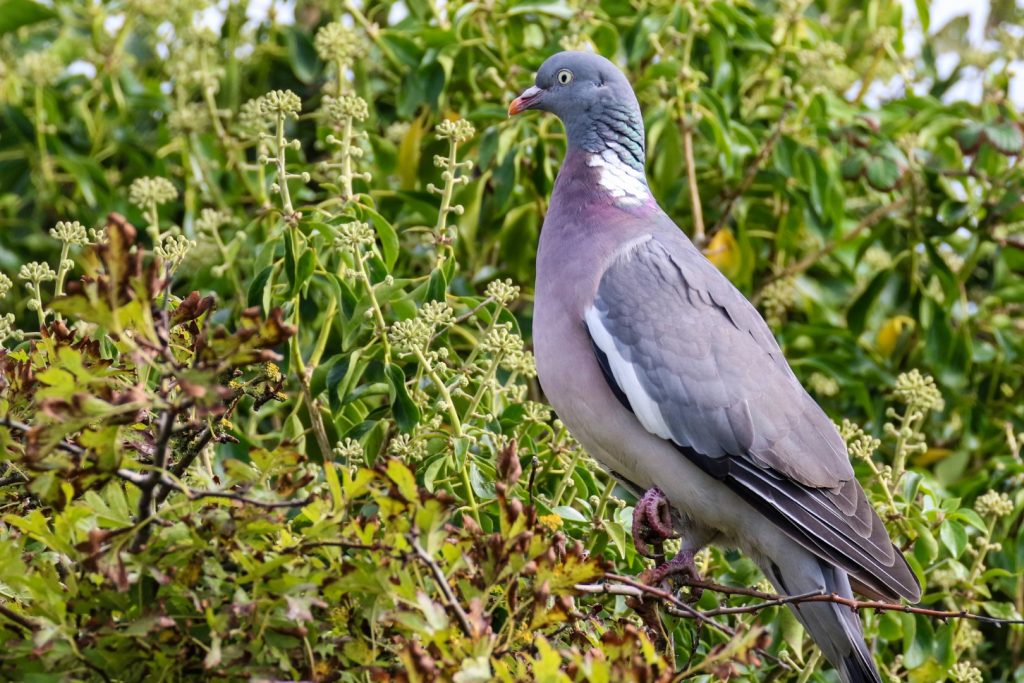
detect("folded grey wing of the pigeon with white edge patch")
(586, 237), (921, 600)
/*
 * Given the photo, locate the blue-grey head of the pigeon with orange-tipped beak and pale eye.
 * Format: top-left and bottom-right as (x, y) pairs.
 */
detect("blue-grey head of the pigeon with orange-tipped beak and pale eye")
(509, 52), (644, 171)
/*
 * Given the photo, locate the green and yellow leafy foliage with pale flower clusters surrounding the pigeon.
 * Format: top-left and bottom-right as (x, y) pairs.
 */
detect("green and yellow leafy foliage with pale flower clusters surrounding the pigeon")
(0, 0), (1024, 683)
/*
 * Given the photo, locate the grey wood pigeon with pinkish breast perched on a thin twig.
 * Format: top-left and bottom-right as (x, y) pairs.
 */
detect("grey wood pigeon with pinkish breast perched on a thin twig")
(509, 52), (921, 683)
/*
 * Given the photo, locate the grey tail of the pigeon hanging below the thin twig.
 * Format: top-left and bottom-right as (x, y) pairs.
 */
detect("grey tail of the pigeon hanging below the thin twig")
(762, 549), (882, 683)
